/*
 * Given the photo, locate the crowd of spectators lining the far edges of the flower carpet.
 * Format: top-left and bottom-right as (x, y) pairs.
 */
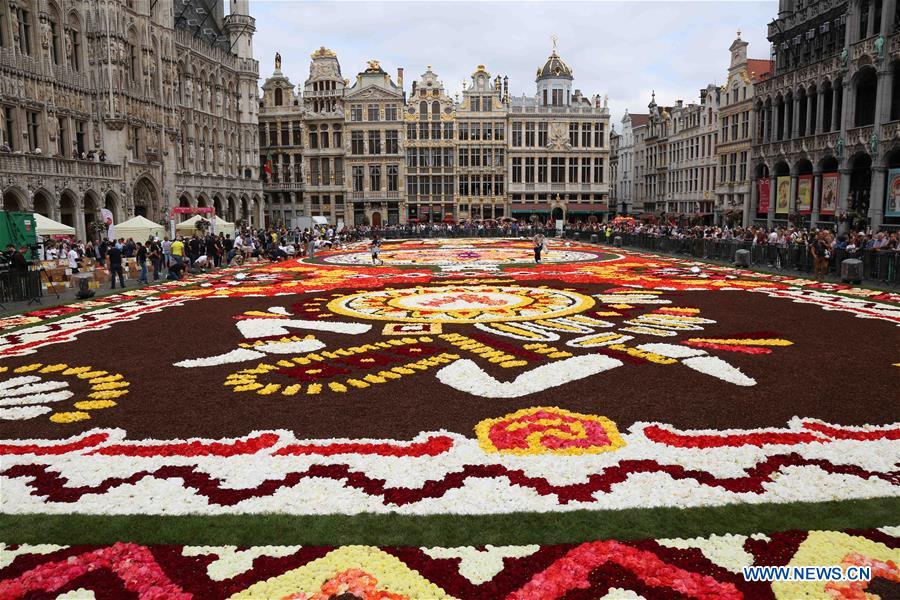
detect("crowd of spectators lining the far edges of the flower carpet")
(29, 219), (900, 288)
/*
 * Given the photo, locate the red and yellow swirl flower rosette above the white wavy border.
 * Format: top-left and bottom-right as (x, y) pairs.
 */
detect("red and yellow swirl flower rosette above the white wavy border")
(475, 407), (625, 454)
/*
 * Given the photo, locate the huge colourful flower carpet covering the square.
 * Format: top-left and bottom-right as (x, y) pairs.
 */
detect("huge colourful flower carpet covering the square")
(0, 239), (900, 599)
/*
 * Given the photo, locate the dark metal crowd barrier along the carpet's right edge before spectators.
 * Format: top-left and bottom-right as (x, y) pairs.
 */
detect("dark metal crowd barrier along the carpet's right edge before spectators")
(592, 231), (900, 286)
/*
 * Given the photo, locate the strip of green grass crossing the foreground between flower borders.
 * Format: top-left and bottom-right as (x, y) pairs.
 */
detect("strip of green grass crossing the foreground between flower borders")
(0, 497), (900, 546)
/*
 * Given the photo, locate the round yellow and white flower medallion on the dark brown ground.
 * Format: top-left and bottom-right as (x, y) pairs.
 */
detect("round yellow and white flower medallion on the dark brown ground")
(328, 285), (594, 323)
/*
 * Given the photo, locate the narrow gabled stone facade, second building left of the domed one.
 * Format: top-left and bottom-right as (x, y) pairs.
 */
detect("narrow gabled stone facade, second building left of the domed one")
(403, 65), (454, 222)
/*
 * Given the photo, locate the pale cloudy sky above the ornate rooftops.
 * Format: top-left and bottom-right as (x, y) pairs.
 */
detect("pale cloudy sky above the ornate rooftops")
(250, 0), (778, 129)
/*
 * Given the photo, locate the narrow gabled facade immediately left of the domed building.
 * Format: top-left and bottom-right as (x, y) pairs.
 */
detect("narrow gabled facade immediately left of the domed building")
(458, 65), (509, 219)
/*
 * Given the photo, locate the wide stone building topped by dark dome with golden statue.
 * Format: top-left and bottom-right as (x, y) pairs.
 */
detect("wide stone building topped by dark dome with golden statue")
(509, 48), (609, 220)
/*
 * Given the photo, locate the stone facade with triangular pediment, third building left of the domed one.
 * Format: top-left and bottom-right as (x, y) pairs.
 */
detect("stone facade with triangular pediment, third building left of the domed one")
(344, 60), (406, 226)
